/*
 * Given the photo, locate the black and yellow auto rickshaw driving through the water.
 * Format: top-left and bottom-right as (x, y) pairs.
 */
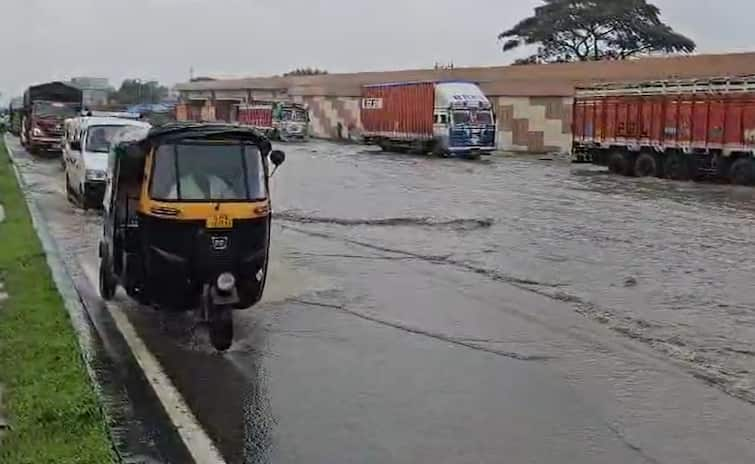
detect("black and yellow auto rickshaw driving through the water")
(99, 123), (285, 351)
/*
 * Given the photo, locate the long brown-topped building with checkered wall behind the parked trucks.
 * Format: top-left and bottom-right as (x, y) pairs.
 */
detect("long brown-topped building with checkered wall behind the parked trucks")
(177, 53), (755, 153)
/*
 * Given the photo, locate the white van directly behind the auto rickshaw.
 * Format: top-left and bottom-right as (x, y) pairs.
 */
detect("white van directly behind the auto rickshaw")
(63, 116), (151, 209)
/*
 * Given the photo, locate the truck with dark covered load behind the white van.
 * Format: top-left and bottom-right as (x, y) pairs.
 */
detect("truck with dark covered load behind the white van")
(21, 82), (82, 153)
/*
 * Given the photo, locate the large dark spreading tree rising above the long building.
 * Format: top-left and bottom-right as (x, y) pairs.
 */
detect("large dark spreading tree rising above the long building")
(498, 0), (696, 64)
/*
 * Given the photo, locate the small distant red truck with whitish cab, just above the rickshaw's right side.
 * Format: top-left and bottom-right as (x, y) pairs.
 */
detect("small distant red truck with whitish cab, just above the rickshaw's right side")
(236, 101), (309, 142)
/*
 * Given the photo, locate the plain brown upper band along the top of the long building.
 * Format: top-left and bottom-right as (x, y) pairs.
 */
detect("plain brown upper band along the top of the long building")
(177, 53), (755, 97)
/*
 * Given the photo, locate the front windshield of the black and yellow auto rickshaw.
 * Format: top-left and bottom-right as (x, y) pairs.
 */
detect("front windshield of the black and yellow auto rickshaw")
(150, 143), (267, 201)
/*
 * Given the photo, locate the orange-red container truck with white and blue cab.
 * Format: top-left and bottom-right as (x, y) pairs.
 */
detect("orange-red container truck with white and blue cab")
(361, 81), (496, 158)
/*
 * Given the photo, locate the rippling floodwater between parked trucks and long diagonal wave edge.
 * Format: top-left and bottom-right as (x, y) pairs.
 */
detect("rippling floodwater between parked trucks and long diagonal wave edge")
(274, 142), (755, 402)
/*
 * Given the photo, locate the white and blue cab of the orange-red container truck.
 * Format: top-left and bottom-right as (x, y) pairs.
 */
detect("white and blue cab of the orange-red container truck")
(433, 82), (496, 157)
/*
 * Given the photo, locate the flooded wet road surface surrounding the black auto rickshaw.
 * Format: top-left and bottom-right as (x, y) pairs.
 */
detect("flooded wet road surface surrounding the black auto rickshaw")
(8, 138), (755, 464)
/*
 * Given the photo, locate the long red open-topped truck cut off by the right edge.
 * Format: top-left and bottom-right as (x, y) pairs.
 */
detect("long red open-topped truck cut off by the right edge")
(572, 76), (755, 185)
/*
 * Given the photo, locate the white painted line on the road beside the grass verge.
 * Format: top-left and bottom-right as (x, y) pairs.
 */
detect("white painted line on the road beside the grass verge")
(79, 216), (225, 464)
